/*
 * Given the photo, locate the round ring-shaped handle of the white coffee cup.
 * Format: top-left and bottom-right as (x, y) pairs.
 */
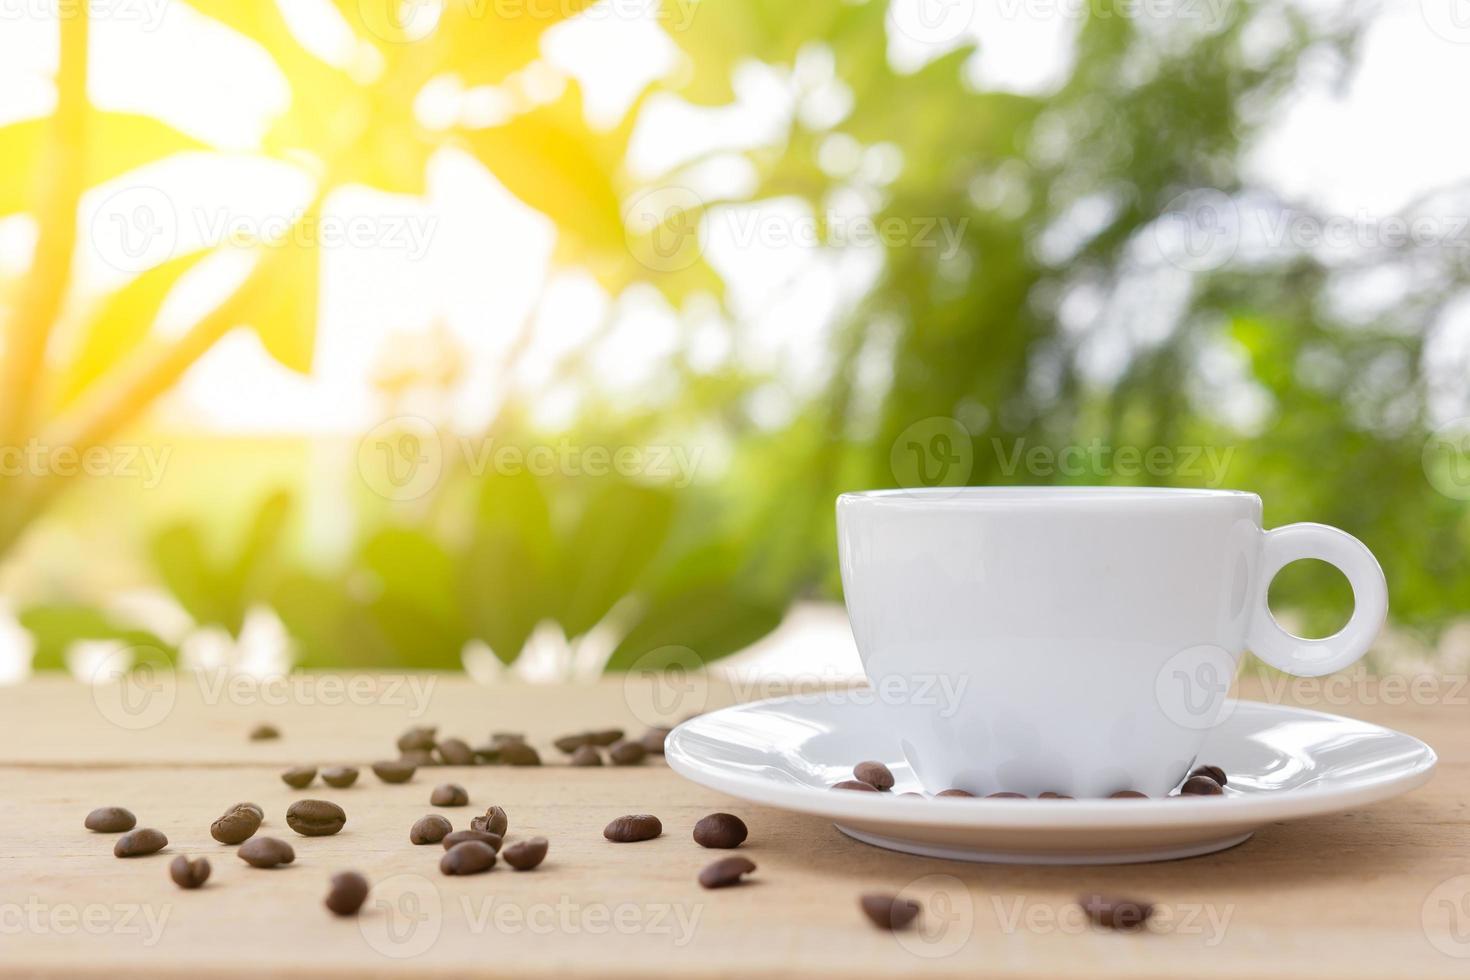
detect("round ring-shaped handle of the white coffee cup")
(1248, 523), (1388, 677)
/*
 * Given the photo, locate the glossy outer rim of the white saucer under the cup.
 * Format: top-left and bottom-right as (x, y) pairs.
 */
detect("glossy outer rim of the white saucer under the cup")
(664, 695), (1439, 830)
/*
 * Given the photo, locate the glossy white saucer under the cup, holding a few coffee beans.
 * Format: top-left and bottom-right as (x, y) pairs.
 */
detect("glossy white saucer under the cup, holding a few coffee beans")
(664, 695), (1436, 864)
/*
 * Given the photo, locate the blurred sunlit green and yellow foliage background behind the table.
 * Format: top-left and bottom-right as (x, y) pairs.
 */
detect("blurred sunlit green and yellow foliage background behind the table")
(0, 0), (1470, 679)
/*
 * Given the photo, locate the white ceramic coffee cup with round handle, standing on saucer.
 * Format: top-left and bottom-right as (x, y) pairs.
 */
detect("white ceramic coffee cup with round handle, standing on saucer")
(836, 486), (1388, 798)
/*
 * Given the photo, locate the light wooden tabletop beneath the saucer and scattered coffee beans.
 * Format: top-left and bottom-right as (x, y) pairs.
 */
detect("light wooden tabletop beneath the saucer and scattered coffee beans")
(0, 674), (1470, 977)
